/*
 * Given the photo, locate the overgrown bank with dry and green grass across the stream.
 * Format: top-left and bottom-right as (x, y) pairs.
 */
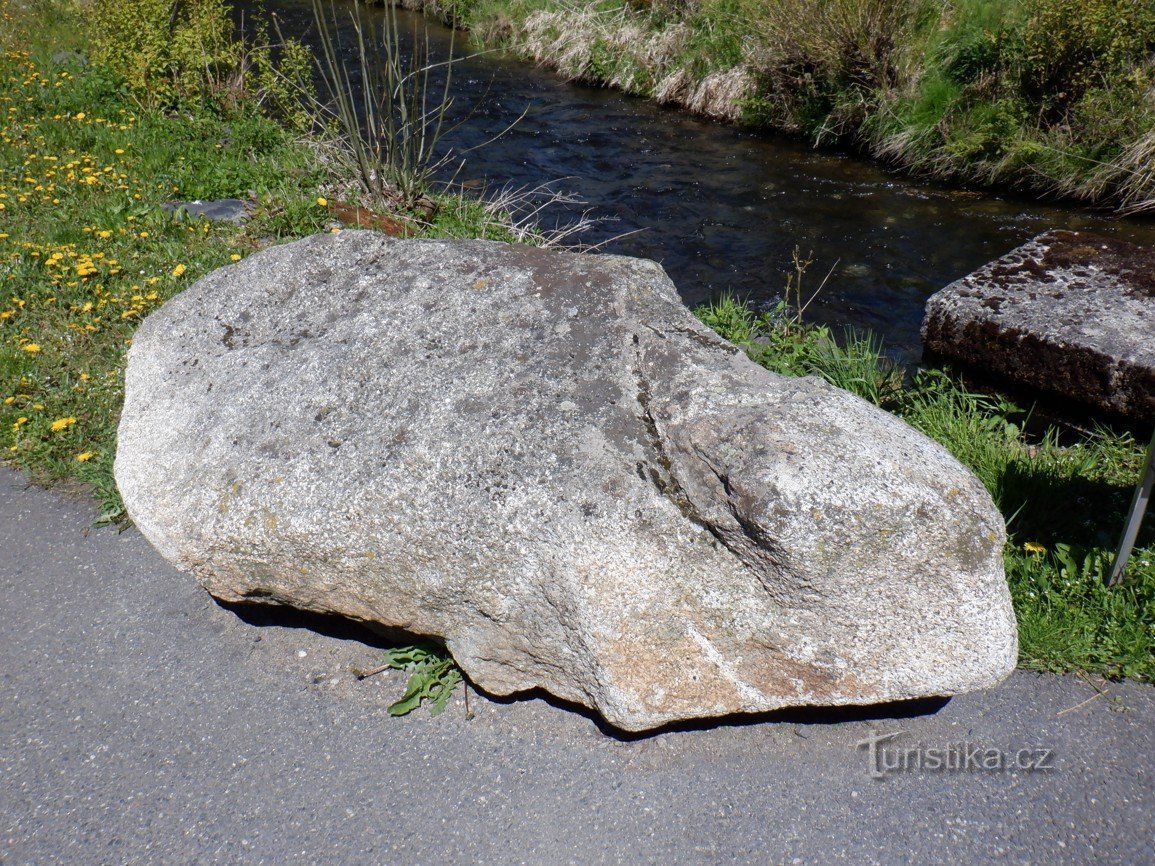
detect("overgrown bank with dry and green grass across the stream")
(415, 0), (1155, 212)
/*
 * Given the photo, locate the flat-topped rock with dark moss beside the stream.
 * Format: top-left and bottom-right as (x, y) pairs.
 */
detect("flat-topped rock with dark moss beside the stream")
(923, 231), (1155, 420)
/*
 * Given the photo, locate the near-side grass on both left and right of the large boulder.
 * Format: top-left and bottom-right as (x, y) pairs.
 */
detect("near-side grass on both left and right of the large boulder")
(0, 5), (1155, 680)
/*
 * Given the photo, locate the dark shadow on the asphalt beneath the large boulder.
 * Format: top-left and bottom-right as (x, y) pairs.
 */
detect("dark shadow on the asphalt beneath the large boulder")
(217, 602), (951, 742)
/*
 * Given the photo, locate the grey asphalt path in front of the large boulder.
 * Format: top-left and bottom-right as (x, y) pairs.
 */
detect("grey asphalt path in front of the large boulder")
(0, 471), (1155, 864)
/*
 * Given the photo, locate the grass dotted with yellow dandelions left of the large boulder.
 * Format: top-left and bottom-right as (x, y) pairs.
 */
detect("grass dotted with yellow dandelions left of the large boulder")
(0, 2), (511, 520)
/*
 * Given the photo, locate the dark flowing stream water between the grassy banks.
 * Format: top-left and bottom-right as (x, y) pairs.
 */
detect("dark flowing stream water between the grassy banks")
(259, 0), (1155, 360)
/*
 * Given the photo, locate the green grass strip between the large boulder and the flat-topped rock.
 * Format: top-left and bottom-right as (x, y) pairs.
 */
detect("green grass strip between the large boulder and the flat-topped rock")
(695, 298), (1155, 681)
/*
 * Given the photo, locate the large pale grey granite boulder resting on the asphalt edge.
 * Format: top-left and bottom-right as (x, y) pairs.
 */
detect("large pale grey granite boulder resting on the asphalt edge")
(116, 232), (1016, 730)
